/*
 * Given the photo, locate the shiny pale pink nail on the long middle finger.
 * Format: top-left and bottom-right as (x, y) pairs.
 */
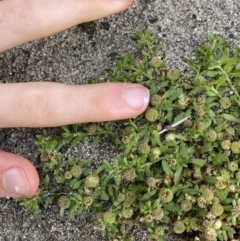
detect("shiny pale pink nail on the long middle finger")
(125, 86), (150, 110)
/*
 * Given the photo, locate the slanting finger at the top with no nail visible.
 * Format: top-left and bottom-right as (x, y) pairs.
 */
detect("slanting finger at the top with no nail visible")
(0, 0), (133, 52)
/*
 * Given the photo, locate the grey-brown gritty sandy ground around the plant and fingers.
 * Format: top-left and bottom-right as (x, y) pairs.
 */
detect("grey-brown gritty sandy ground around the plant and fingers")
(0, 0), (240, 241)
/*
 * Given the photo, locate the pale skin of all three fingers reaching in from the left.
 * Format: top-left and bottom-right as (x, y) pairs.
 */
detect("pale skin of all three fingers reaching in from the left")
(0, 0), (149, 197)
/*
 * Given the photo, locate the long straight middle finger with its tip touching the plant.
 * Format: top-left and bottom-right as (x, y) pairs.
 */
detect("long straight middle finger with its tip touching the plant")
(0, 82), (149, 127)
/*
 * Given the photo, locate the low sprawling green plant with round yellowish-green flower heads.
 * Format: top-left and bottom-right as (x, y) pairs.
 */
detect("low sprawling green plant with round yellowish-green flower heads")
(18, 31), (240, 241)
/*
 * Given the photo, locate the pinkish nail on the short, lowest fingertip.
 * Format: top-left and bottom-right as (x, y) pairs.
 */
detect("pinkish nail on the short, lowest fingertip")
(3, 167), (29, 197)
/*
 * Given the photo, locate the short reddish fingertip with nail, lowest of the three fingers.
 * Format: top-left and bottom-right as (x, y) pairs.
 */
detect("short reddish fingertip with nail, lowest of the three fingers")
(0, 152), (39, 197)
